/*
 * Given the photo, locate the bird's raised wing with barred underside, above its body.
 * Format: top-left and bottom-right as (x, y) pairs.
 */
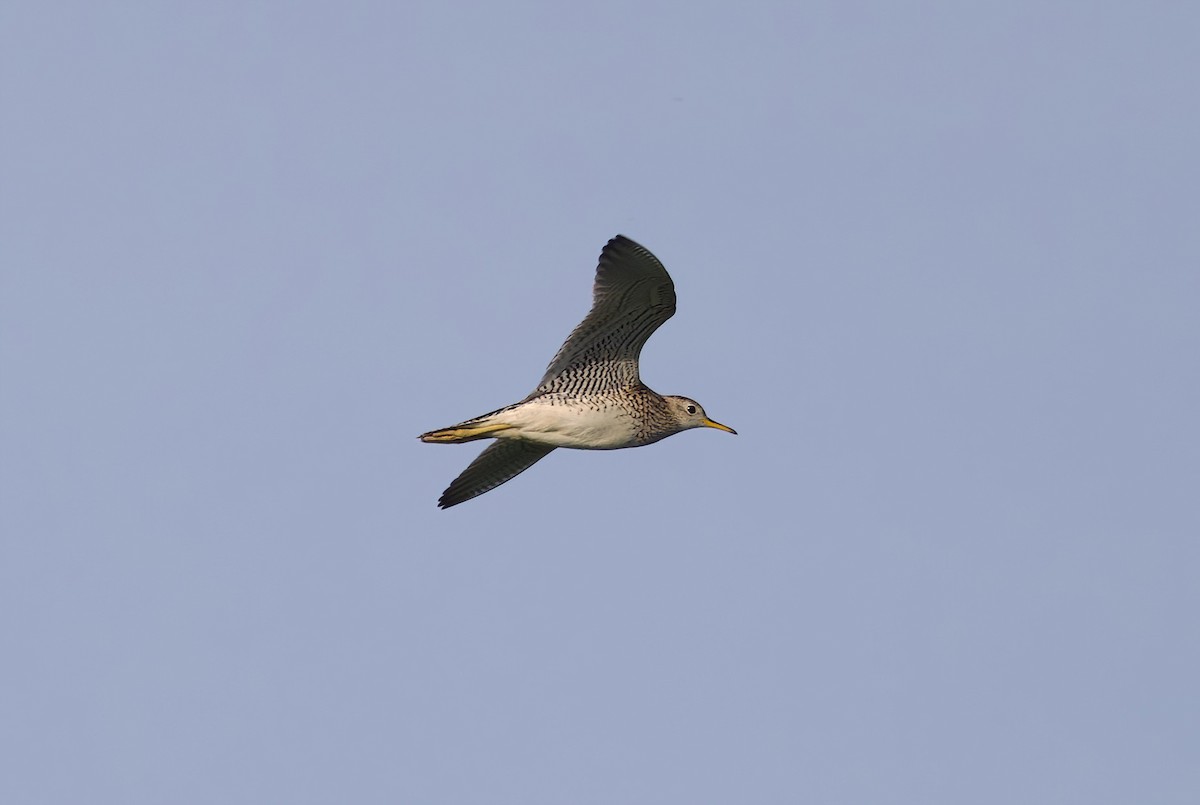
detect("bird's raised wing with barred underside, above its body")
(534, 235), (676, 395)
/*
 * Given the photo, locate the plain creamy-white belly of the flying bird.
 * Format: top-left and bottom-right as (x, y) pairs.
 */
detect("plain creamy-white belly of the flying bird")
(496, 401), (637, 450)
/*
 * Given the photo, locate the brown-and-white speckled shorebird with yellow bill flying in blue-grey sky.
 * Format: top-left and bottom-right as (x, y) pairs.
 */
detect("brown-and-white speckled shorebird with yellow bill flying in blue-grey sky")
(418, 235), (737, 509)
